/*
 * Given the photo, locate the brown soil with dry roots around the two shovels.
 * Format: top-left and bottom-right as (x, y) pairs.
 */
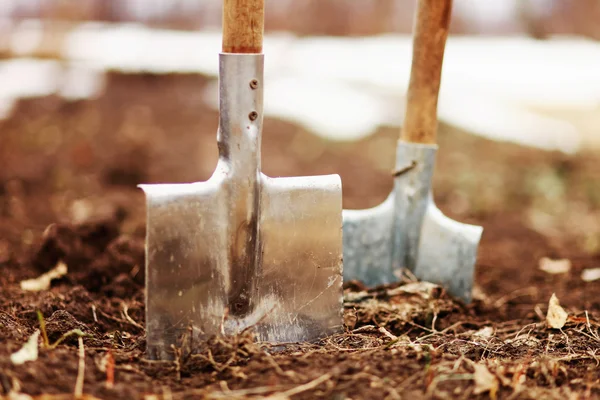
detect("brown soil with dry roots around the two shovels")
(0, 73), (600, 399)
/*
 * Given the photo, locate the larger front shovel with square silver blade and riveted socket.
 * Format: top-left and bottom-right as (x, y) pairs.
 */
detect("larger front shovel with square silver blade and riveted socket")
(140, 0), (342, 359)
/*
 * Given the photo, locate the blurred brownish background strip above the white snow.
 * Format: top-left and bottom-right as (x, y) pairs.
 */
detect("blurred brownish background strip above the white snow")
(0, 0), (600, 38)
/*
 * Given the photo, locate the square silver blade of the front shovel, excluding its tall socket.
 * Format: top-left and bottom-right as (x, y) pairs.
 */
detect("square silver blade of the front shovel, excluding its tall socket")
(138, 174), (342, 359)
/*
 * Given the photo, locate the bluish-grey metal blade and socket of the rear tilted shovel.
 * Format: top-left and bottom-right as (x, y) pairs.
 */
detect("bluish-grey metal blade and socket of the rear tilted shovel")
(343, 141), (483, 303)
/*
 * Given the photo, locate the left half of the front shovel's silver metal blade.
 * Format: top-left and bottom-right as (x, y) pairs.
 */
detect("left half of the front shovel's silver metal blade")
(140, 182), (229, 359)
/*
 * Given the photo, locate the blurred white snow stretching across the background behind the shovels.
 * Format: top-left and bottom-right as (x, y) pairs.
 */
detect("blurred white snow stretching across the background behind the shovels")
(0, 21), (600, 153)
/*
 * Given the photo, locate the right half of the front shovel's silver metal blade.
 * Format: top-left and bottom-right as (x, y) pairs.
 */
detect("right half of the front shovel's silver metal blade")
(257, 175), (343, 342)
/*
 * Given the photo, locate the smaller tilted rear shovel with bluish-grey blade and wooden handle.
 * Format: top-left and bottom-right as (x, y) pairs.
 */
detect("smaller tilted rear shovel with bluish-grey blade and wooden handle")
(343, 0), (483, 303)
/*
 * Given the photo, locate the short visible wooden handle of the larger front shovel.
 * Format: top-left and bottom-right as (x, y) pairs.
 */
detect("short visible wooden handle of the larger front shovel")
(223, 0), (265, 54)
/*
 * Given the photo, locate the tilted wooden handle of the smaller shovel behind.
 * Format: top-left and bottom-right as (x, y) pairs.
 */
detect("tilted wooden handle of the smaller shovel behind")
(400, 0), (452, 143)
